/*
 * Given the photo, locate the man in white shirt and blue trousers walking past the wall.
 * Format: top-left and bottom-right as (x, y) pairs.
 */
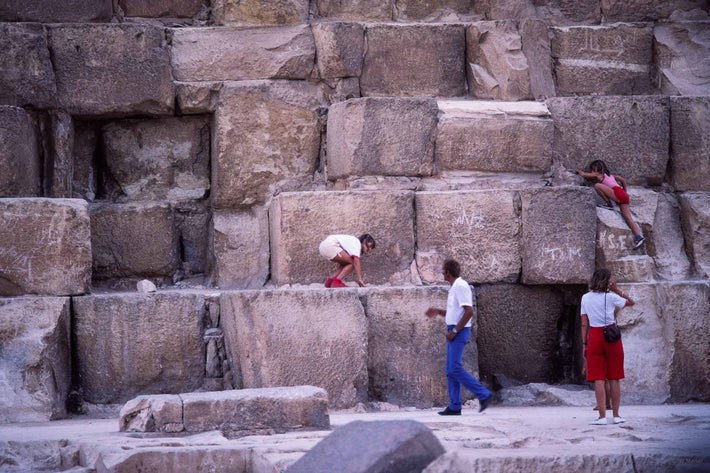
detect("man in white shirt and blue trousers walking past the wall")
(426, 260), (491, 416)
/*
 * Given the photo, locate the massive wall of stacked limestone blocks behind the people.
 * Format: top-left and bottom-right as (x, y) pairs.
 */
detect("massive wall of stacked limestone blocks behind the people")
(0, 0), (710, 430)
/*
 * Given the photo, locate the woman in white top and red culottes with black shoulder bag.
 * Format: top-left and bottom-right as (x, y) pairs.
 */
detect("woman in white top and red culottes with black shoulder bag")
(581, 268), (636, 425)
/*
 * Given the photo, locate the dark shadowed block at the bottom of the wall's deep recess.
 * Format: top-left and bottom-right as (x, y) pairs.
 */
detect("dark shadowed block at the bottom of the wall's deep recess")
(91, 202), (179, 279)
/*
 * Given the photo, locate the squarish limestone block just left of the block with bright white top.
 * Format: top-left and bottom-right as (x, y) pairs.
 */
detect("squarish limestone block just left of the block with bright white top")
(327, 97), (438, 180)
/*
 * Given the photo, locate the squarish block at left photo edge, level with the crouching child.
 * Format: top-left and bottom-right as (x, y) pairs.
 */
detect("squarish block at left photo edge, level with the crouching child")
(0, 199), (91, 296)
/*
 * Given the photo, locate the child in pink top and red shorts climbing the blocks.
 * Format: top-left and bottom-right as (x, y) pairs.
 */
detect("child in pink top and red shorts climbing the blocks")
(577, 159), (646, 250)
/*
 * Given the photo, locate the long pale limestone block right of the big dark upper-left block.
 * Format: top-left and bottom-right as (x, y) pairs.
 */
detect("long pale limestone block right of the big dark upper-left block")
(172, 25), (315, 81)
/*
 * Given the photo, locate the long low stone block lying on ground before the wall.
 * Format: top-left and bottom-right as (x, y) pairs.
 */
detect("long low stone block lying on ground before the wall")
(119, 386), (330, 438)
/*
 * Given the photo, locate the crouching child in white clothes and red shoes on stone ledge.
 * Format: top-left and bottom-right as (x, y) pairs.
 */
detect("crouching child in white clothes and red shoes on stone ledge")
(318, 233), (375, 287)
